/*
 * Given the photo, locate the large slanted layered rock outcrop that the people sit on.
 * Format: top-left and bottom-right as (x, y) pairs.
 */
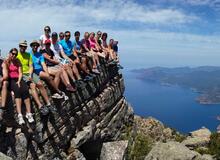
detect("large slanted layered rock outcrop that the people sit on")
(0, 65), (133, 160)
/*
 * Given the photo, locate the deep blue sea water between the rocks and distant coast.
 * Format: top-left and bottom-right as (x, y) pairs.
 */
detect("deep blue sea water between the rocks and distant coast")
(123, 71), (220, 133)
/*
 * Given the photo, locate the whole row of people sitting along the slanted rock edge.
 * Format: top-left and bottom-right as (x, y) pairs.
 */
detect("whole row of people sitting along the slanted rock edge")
(0, 26), (122, 125)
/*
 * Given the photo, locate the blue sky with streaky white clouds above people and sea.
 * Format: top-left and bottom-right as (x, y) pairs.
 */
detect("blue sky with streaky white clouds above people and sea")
(0, 0), (220, 69)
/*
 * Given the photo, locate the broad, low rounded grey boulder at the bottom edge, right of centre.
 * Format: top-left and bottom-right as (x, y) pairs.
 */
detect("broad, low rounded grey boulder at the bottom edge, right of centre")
(145, 142), (204, 160)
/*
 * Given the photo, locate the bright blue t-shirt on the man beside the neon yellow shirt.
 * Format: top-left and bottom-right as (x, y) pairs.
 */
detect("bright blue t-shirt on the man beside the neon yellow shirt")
(30, 51), (45, 70)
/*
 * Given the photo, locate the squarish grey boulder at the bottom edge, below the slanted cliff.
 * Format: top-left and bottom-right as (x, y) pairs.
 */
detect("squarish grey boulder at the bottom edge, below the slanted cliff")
(100, 141), (128, 160)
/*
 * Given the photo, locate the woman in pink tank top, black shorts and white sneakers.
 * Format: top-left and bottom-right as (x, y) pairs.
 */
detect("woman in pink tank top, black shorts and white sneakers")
(5, 48), (34, 125)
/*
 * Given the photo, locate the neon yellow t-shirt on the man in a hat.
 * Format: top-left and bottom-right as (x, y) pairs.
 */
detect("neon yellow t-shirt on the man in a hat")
(17, 52), (33, 74)
